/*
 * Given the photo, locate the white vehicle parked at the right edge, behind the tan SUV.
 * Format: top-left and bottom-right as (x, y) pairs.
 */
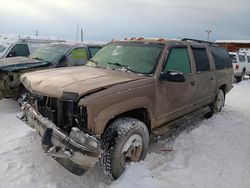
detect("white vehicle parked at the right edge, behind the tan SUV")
(229, 51), (250, 82)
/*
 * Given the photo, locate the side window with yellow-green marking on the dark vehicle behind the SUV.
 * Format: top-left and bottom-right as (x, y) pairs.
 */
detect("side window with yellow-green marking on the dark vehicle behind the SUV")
(67, 48), (88, 66)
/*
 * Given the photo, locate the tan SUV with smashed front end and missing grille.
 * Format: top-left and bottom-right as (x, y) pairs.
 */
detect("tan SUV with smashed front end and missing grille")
(21, 38), (234, 179)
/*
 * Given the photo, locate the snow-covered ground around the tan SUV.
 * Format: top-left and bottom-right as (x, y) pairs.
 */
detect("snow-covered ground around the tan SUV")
(0, 80), (250, 188)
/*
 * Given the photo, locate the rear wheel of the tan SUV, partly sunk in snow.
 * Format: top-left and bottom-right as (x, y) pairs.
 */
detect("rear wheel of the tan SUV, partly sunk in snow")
(205, 89), (225, 118)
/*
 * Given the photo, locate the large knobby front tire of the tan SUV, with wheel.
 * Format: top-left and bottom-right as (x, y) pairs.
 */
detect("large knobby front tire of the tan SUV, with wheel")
(100, 117), (149, 179)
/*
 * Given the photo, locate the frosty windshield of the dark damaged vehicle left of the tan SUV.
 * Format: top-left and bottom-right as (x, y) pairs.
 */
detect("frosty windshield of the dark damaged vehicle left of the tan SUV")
(30, 45), (69, 64)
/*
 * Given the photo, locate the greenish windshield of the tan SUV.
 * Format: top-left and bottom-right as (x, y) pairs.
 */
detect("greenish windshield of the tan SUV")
(87, 42), (163, 74)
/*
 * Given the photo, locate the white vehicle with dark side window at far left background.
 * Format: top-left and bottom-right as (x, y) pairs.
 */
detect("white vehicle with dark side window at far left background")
(0, 38), (65, 59)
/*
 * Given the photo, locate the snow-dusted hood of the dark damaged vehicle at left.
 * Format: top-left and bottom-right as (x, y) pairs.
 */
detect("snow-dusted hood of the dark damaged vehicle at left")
(0, 57), (50, 72)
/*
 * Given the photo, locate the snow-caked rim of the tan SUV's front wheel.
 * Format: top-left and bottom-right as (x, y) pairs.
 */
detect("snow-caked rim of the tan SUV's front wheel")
(121, 134), (142, 167)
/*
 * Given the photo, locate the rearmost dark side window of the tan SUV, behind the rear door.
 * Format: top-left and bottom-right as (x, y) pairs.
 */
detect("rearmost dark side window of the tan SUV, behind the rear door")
(210, 46), (232, 69)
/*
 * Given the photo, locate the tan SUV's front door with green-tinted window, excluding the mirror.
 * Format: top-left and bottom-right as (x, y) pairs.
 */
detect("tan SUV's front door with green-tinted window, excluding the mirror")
(156, 45), (194, 126)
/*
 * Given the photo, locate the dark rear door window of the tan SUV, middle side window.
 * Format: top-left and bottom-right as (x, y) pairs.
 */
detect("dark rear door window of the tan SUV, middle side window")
(192, 47), (210, 73)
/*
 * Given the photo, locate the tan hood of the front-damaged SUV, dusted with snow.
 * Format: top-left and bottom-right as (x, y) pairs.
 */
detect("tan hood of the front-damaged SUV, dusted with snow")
(20, 66), (145, 98)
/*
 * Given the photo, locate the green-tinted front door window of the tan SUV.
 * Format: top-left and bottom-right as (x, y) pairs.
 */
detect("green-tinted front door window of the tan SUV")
(164, 47), (191, 74)
